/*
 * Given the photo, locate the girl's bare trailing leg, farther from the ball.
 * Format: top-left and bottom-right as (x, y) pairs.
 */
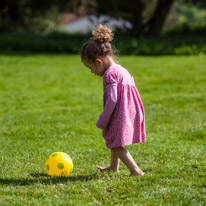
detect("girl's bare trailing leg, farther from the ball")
(112, 147), (145, 176)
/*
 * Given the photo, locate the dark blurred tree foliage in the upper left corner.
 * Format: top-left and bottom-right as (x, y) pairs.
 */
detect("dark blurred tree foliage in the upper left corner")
(0, 0), (80, 31)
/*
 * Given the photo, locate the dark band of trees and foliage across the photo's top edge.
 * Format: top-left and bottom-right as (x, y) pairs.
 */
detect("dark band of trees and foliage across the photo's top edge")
(0, 0), (206, 37)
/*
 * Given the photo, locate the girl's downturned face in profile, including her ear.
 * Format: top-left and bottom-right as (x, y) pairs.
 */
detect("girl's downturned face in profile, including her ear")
(83, 59), (106, 77)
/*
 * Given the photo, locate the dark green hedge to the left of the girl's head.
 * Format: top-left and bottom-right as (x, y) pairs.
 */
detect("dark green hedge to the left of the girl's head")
(0, 32), (86, 54)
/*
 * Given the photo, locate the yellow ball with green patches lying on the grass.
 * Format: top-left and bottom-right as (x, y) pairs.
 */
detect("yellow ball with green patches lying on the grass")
(45, 152), (74, 176)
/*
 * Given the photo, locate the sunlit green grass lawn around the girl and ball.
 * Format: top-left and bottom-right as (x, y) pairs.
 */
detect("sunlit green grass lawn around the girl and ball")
(0, 55), (206, 206)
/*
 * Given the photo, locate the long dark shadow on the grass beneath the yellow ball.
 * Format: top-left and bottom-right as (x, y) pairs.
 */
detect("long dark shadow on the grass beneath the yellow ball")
(0, 173), (99, 186)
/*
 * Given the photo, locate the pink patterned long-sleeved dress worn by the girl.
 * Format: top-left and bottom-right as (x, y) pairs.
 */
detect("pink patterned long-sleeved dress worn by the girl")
(96, 65), (146, 149)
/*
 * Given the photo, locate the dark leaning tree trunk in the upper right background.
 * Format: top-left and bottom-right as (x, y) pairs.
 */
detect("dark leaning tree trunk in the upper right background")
(146, 0), (174, 37)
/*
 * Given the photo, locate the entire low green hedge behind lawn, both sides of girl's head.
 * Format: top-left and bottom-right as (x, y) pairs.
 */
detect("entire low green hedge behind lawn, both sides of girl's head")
(0, 28), (206, 55)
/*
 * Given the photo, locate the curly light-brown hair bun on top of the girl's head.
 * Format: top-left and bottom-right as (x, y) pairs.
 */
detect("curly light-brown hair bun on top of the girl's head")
(92, 24), (114, 42)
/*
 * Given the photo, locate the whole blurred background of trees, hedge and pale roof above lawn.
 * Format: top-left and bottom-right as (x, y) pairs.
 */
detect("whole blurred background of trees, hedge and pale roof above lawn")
(0, 0), (206, 56)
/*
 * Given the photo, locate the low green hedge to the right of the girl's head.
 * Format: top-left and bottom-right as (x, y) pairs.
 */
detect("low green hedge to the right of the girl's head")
(114, 36), (206, 55)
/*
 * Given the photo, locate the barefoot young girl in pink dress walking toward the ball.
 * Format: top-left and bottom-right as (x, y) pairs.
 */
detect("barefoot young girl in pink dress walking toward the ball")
(81, 24), (146, 176)
